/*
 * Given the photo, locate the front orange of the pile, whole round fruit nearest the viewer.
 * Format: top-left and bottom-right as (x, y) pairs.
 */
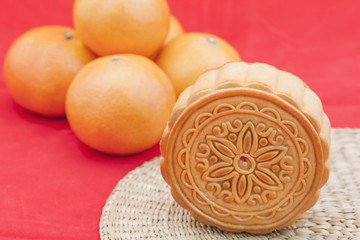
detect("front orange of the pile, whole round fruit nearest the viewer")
(66, 54), (176, 155)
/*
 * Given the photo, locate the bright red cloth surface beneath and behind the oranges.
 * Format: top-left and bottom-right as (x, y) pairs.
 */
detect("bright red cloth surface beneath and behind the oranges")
(0, 0), (360, 240)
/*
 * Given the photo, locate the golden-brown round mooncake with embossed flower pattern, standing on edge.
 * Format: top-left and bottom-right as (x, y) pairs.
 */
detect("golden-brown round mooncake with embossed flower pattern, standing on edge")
(161, 62), (331, 234)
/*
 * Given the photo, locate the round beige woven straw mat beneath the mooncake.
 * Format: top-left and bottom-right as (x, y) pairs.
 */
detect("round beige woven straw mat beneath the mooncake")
(100, 129), (360, 240)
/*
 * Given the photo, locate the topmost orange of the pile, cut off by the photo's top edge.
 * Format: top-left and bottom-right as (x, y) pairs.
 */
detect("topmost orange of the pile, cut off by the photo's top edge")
(73, 0), (170, 57)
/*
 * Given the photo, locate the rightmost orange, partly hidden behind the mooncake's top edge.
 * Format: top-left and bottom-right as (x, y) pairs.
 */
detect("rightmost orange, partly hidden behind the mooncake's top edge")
(156, 33), (241, 95)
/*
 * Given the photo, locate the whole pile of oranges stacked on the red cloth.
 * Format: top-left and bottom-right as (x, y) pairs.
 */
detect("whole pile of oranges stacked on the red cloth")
(4, 0), (240, 155)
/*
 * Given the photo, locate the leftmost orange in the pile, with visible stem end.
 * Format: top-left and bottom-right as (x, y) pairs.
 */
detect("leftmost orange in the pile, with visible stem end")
(4, 26), (96, 116)
